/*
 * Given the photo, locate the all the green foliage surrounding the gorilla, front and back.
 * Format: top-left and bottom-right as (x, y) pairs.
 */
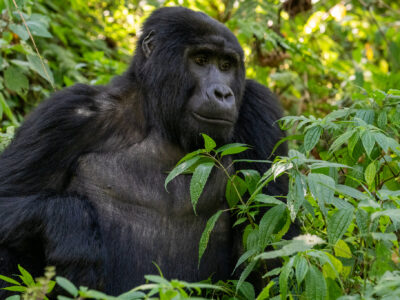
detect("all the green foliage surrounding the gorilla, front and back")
(0, 0), (400, 299)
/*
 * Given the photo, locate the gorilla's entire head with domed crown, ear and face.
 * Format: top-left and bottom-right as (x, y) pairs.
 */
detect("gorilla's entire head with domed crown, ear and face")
(128, 7), (245, 150)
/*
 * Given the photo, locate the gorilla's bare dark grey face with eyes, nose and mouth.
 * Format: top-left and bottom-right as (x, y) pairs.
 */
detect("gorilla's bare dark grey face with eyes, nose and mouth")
(181, 44), (241, 148)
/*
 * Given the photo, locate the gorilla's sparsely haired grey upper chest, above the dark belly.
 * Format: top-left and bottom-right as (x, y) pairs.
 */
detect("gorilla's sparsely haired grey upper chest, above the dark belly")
(69, 135), (227, 216)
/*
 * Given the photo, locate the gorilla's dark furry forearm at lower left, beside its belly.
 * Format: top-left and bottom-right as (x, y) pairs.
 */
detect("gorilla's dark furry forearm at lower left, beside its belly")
(0, 194), (104, 292)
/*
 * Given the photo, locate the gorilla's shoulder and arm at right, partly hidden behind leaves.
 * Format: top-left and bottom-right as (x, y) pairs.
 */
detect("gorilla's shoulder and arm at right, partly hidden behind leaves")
(234, 80), (288, 195)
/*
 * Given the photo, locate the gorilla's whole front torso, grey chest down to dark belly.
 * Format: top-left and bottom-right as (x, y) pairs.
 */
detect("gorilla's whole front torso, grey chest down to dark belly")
(69, 136), (232, 291)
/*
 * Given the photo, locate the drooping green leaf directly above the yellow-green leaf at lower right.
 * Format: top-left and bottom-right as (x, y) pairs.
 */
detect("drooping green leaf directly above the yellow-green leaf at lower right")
(327, 209), (353, 245)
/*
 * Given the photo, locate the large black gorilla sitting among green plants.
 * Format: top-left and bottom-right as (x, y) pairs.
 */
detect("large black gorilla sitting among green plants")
(0, 7), (287, 294)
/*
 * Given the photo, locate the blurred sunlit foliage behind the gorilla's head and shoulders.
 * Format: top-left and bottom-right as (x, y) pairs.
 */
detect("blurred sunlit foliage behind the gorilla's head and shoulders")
(0, 0), (400, 131)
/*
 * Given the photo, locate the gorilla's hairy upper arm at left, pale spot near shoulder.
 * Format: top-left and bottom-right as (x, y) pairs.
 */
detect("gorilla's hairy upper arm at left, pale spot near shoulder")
(0, 84), (105, 197)
